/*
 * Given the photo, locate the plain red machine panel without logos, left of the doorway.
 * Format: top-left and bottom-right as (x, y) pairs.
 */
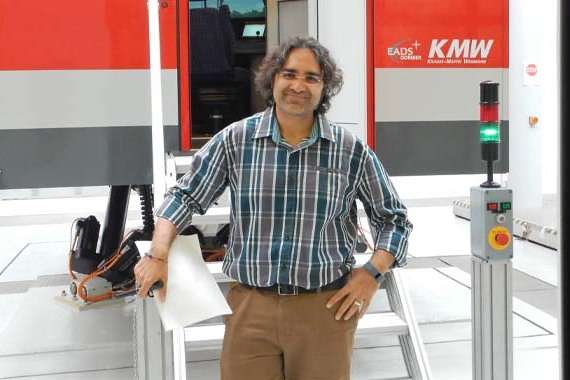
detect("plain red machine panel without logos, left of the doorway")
(0, 0), (176, 70)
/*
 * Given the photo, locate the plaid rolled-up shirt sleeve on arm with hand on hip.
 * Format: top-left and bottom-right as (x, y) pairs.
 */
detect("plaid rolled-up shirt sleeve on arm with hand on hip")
(358, 148), (413, 267)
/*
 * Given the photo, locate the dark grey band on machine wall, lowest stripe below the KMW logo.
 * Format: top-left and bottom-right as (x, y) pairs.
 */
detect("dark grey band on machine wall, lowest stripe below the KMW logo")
(376, 120), (509, 176)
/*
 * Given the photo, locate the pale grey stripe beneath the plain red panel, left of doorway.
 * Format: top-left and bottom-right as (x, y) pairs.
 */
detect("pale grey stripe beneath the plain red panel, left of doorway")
(0, 69), (178, 130)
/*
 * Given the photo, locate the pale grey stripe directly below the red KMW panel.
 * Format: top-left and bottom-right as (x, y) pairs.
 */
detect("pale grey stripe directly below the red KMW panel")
(375, 68), (509, 122)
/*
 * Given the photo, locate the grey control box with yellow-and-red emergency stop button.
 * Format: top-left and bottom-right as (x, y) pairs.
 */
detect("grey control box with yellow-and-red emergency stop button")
(470, 186), (513, 261)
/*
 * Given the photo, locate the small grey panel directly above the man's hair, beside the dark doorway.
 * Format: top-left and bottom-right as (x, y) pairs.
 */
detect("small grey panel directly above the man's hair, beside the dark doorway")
(279, 0), (309, 43)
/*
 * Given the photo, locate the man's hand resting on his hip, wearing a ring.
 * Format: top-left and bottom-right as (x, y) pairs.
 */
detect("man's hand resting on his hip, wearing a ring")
(327, 268), (378, 320)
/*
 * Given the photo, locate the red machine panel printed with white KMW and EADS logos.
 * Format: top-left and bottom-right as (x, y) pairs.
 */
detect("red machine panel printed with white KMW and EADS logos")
(374, 0), (509, 68)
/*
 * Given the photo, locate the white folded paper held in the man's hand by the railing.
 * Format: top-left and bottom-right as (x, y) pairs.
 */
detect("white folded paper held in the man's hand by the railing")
(136, 235), (232, 331)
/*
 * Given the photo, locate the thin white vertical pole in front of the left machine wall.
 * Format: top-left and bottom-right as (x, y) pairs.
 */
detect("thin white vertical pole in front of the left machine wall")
(147, 0), (166, 205)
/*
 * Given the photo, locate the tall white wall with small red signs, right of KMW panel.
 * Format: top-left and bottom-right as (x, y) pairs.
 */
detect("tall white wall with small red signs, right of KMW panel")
(508, 0), (560, 210)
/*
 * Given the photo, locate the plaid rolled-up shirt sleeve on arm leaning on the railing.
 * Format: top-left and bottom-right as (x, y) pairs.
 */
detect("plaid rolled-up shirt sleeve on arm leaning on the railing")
(156, 130), (228, 233)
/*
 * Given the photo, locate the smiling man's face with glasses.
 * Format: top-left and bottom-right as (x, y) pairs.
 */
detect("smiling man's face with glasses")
(273, 48), (323, 117)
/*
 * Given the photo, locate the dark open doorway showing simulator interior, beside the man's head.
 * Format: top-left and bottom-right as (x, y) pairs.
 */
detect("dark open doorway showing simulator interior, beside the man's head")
(189, 0), (267, 149)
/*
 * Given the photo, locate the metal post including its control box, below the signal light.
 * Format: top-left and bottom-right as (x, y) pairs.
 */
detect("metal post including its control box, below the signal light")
(471, 187), (513, 380)
